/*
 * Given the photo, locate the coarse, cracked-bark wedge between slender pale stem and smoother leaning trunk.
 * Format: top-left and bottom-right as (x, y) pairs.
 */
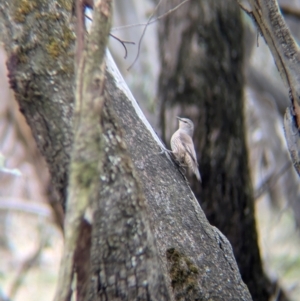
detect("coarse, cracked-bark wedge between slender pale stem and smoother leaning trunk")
(86, 94), (170, 301)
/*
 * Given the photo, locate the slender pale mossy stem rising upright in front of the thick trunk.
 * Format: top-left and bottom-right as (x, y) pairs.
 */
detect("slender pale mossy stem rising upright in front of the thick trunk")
(55, 0), (112, 301)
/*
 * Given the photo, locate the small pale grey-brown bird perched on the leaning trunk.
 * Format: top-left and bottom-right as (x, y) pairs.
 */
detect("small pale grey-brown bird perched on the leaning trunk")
(170, 116), (201, 182)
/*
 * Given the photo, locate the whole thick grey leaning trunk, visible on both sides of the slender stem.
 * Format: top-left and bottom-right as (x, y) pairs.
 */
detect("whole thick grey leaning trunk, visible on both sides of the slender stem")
(0, 1), (251, 300)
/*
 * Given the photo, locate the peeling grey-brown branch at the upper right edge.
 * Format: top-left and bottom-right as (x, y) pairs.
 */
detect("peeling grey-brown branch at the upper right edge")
(240, 0), (300, 175)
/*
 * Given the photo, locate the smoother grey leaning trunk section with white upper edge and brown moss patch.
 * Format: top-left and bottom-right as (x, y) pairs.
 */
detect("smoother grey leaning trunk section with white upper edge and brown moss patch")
(100, 50), (251, 300)
